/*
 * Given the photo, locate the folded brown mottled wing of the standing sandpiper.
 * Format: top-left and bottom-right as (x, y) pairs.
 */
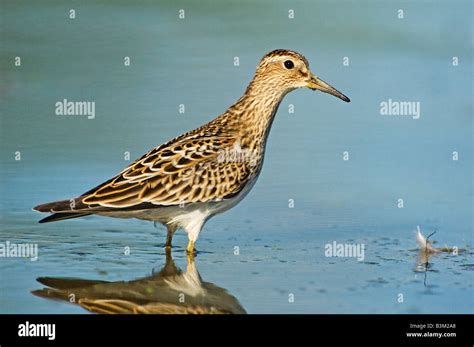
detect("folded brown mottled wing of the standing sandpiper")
(79, 135), (252, 208)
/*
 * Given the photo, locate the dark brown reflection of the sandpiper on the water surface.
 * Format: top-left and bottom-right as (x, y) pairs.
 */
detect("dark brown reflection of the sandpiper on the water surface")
(32, 252), (246, 314)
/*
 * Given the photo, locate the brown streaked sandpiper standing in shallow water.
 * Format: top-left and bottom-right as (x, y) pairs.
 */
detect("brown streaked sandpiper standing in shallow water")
(33, 49), (350, 254)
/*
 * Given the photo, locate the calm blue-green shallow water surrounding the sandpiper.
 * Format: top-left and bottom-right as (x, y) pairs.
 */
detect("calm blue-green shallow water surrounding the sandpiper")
(0, 1), (474, 313)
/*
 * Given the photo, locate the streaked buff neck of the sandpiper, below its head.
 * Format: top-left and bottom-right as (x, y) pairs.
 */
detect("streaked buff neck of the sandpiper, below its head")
(227, 79), (288, 150)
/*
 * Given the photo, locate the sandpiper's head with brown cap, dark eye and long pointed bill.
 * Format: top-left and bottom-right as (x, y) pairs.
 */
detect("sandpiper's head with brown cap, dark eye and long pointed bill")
(255, 49), (350, 102)
